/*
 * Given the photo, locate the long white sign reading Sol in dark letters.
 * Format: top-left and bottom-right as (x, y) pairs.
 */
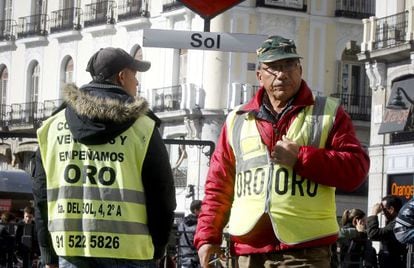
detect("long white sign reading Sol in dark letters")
(142, 29), (267, 52)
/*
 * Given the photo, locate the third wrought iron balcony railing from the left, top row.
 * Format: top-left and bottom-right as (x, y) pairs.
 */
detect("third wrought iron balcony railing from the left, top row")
(50, 7), (82, 33)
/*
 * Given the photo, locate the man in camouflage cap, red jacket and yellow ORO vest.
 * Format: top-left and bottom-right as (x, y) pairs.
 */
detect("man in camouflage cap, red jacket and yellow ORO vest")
(194, 36), (369, 268)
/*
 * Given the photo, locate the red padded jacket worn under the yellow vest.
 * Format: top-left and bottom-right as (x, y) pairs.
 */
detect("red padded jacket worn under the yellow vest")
(194, 80), (369, 255)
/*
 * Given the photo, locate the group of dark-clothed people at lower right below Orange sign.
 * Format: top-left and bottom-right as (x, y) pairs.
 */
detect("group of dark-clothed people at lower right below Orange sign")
(332, 195), (414, 268)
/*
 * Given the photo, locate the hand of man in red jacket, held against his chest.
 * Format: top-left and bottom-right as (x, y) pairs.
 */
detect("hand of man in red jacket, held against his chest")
(270, 136), (299, 167)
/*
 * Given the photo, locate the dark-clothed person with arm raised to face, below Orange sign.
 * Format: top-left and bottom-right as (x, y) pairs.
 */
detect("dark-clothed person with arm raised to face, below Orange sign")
(367, 195), (407, 268)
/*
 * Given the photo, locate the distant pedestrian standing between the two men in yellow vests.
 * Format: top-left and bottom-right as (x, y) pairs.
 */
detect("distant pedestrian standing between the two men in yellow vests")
(178, 200), (201, 268)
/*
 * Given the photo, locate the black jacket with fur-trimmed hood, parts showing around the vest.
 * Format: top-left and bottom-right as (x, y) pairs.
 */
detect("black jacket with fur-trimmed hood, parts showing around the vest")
(33, 82), (176, 264)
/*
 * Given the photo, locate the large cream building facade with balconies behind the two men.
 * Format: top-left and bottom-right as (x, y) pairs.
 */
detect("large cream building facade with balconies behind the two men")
(0, 0), (375, 215)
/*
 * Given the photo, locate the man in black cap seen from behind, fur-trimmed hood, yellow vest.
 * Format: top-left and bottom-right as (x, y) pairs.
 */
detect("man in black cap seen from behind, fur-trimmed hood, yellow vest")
(33, 47), (176, 267)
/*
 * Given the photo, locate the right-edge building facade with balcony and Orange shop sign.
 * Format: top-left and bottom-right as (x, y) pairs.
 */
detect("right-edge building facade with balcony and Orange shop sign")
(358, 0), (414, 216)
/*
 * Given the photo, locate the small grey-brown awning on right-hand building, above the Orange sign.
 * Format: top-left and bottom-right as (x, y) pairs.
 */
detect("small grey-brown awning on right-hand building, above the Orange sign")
(378, 109), (412, 134)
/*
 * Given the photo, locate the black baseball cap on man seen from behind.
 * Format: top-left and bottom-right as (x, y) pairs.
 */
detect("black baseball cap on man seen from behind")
(86, 47), (151, 81)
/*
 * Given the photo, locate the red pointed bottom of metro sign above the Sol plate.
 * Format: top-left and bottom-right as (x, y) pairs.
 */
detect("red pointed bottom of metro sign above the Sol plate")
(178, 0), (244, 19)
